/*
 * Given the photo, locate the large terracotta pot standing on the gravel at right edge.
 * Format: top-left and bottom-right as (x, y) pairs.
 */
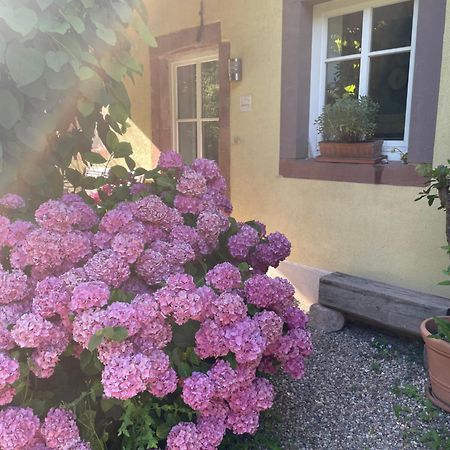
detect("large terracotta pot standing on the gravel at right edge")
(420, 317), (450, 412)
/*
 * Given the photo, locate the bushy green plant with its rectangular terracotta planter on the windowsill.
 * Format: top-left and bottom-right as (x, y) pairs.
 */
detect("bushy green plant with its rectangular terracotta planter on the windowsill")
(316, 96), (383, 164)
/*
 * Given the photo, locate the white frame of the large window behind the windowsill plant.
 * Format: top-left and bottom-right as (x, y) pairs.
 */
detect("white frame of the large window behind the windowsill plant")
(309, 0), (420, 161)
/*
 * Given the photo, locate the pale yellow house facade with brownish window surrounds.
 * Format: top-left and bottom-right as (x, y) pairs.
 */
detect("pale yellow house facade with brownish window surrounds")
(125, 0), (450, 301)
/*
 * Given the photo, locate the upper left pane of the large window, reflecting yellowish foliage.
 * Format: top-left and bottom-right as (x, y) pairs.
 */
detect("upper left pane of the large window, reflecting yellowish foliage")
(327, 11), (363, 58)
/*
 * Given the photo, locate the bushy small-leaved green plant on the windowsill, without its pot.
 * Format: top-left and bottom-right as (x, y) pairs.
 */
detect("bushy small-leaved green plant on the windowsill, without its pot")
(315, 95), (379, 142)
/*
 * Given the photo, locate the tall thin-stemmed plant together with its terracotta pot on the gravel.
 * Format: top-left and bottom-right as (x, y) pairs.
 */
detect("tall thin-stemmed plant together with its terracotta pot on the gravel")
(416, 164), (450, 412)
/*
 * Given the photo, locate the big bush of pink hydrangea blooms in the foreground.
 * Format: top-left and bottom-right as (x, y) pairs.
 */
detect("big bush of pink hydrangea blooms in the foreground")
(0, 152), (312, 450)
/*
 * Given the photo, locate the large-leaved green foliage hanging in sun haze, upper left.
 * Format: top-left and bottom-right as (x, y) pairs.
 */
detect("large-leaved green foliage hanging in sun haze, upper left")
(0, 0), (156, 204)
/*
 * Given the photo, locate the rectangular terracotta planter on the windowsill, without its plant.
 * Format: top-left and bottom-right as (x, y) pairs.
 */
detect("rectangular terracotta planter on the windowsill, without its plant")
(316, 140), (384, 164)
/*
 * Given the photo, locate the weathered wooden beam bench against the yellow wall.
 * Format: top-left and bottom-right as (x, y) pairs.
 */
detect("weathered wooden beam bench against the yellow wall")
(319, 272), (450, 336)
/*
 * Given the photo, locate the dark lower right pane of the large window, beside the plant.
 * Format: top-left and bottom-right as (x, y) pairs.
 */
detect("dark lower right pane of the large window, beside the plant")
(369, 52), (409, 140)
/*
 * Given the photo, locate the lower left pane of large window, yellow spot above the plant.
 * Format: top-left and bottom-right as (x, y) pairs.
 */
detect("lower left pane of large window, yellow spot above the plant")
(325, 59), (360, 103)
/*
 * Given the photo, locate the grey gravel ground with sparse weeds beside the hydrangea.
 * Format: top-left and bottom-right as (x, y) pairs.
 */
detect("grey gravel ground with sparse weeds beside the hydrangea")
(273, 324), (450, 450)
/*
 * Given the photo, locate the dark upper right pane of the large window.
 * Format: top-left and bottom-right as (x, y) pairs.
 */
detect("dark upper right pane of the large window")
(372, 1), (414, 51)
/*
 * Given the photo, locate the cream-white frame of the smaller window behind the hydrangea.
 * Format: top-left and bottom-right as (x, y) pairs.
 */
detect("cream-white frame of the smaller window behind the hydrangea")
(170, 50), (219, 158)
